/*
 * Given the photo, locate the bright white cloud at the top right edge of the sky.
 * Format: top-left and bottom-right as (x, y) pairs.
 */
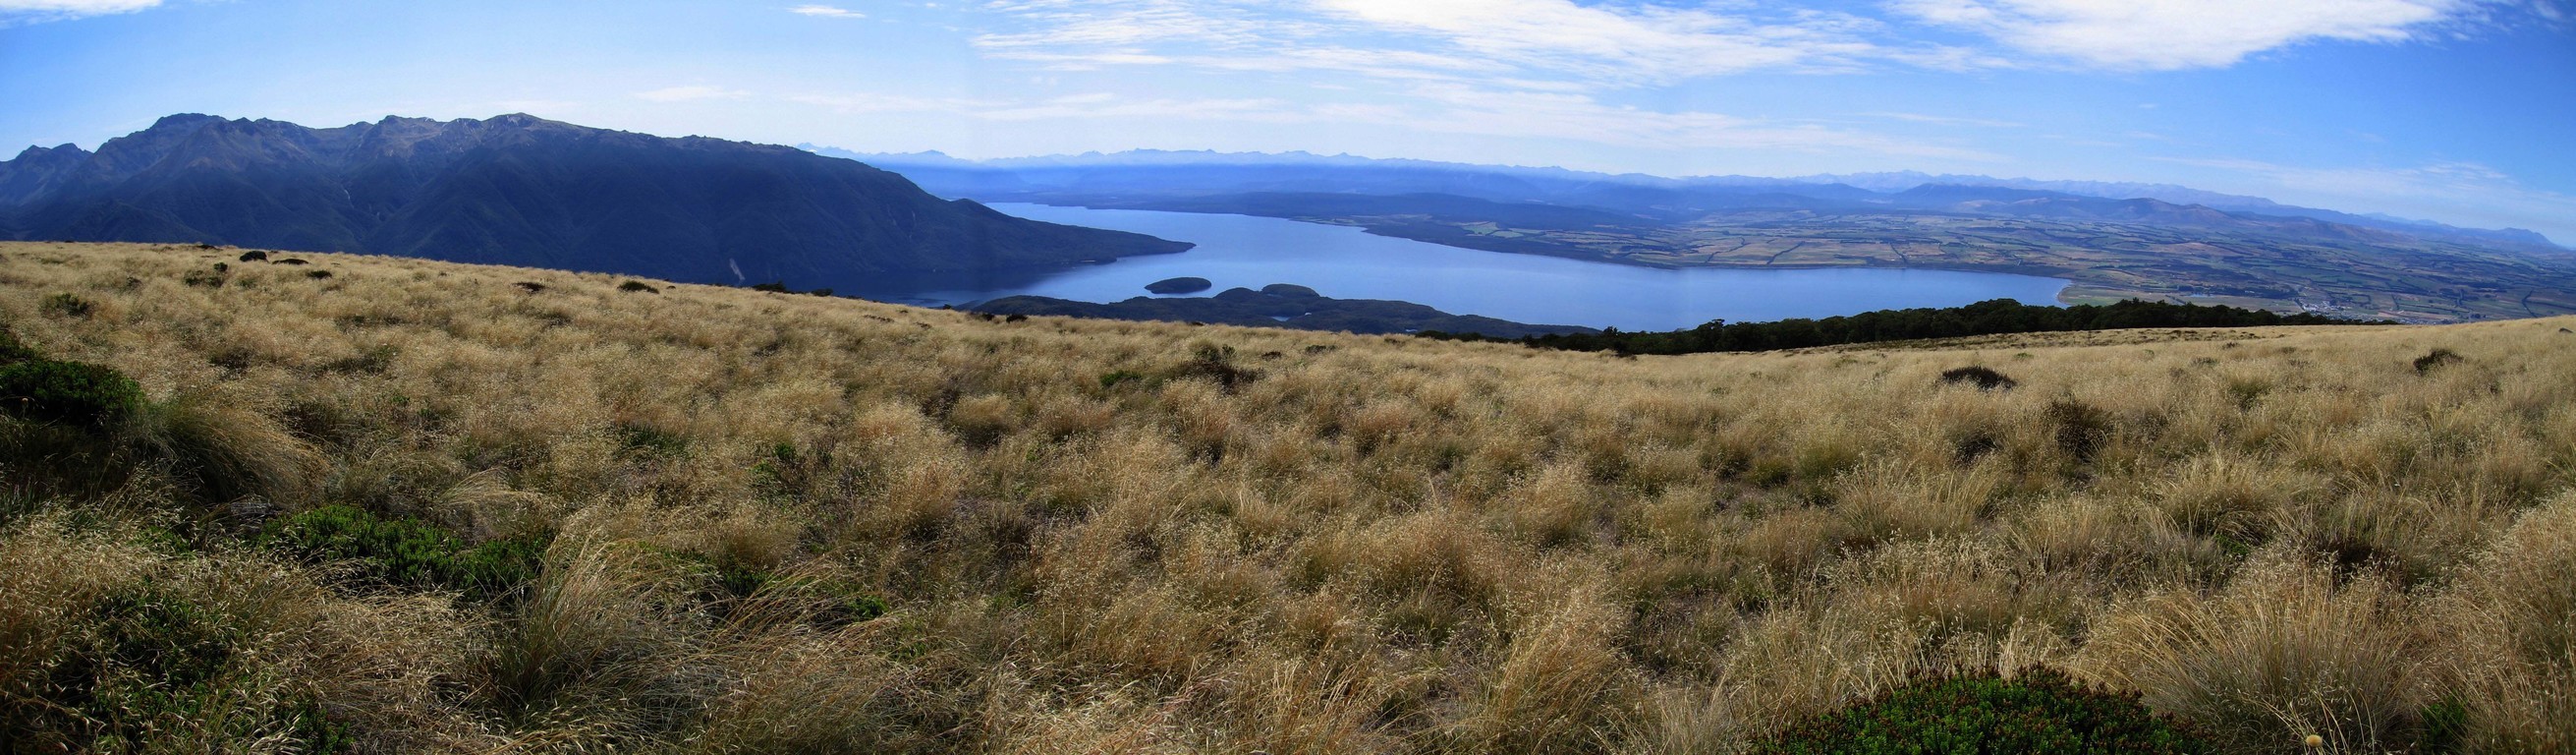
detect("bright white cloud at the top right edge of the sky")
(1891, 0), (2481, 70)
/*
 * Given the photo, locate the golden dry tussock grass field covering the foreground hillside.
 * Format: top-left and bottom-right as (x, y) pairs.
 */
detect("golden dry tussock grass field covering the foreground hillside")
(0, 242), (2576, 755)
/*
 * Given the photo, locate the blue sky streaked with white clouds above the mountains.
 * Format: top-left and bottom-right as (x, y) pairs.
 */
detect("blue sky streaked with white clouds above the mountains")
(15, 0), (2576, 245)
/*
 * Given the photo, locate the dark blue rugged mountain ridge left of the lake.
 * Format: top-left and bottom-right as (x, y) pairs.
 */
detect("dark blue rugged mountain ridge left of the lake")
(0, 113), (1190, 286)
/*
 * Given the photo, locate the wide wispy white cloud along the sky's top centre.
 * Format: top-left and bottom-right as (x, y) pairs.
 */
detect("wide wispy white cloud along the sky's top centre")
(977, 0), (1936, 85)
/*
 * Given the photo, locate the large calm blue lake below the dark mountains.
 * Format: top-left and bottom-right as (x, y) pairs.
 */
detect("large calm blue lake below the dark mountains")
(835, 203), (2066, 330)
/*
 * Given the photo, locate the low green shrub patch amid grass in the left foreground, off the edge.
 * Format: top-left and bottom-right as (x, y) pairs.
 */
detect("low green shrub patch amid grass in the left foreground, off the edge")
(260, 505), (546, 601)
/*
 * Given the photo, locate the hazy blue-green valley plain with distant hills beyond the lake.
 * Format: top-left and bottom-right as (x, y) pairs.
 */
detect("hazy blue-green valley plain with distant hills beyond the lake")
(821, 149), (2576, 322)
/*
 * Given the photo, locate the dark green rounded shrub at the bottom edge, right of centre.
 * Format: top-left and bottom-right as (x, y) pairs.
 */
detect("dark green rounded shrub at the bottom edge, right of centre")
(1752, 668), (2211, 755)
